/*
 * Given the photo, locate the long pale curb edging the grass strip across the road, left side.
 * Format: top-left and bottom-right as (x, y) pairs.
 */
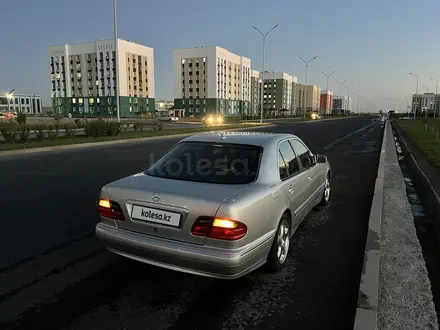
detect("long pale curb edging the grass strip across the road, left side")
(0, 124), (274, 158)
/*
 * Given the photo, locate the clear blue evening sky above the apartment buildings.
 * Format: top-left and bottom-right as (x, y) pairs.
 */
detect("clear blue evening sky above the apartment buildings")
(0, 0), (440, 112)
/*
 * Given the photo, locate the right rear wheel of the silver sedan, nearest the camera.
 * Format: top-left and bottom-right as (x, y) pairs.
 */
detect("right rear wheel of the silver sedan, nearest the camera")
(266, 213), (292, 273)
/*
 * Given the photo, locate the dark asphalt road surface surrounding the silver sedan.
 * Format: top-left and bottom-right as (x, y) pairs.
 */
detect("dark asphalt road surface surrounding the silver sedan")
(0, 118), (382, 330)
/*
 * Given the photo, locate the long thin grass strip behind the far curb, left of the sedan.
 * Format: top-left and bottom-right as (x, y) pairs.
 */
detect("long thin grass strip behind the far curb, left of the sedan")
(0, 123), (267, 152)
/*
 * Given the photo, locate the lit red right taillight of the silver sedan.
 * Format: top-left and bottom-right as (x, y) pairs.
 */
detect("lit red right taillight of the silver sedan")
(191, 217), (247, 241)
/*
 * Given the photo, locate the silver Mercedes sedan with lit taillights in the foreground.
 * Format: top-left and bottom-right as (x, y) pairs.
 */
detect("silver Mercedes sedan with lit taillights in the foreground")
(96, 133), (332, 279)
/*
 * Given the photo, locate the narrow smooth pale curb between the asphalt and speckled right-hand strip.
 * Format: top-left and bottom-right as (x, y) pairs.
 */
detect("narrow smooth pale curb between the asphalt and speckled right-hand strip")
(353, 122), (391, 330)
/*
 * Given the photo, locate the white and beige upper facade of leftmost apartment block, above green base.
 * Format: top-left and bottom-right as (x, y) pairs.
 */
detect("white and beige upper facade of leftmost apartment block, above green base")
(49, 39), (154, 98)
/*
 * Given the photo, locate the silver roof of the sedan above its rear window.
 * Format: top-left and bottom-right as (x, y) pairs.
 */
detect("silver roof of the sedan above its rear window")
(182, 132), (297, 146)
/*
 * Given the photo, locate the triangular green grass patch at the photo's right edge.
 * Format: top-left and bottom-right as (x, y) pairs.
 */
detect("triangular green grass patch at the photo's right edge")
(395, 119), (440, 169)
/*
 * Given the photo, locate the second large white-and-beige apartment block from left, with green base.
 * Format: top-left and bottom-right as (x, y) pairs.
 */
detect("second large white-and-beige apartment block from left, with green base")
(174, 46), (251, 116)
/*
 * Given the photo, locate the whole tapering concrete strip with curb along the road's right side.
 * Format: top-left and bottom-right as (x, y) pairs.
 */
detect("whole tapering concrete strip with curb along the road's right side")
(354, 123), (438, 330)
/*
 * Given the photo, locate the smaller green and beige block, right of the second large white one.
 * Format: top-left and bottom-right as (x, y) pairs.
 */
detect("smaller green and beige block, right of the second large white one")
(260, 71), (298, 115)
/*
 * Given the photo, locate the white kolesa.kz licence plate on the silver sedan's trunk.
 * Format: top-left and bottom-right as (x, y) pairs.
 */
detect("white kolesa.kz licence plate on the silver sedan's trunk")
(131, 205), (182, 228)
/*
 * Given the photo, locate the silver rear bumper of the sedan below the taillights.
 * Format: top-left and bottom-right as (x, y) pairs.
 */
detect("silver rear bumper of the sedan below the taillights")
(96, 222), (274, 279)
